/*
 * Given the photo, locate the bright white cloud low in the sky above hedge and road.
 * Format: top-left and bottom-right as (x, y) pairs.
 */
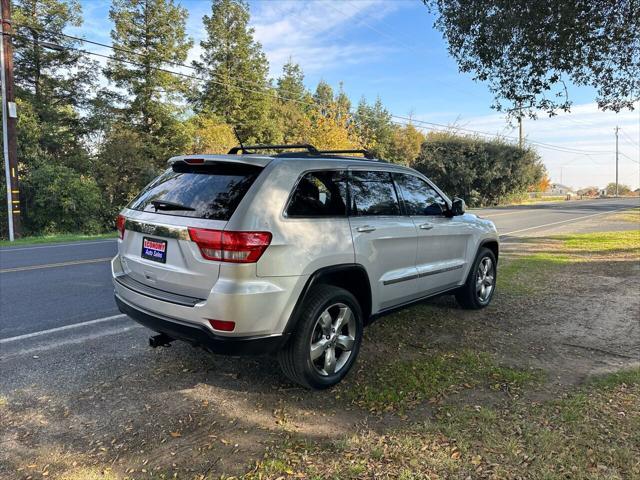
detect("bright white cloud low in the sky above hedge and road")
(415, 103), (640, 188)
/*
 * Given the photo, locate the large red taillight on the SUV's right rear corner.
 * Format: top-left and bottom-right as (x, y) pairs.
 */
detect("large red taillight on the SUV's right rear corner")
(189, 227), (271, 263)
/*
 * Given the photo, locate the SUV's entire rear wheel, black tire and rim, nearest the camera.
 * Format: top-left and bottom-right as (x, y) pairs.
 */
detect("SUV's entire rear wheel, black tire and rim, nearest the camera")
(278, 285), (363, 390)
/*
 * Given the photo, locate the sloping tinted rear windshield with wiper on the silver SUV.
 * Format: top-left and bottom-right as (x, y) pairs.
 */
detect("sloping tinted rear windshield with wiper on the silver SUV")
(129, 163), (262, 220)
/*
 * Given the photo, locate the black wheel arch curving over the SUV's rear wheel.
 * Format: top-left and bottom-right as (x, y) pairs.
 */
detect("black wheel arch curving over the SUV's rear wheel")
(284, 263), (372, 334)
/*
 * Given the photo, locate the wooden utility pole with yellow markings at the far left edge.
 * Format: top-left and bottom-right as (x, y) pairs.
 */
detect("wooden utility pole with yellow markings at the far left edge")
(0, 0), (22, 241)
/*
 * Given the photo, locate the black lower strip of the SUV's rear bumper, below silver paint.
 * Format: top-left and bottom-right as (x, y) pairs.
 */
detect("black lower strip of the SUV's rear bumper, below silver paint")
(115, 294), (288, 355)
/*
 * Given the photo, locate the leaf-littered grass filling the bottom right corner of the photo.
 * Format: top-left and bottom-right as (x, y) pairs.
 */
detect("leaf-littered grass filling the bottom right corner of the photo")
(246, 369), (640, 480)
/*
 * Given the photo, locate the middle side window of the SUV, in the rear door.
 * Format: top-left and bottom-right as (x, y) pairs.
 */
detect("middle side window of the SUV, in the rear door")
(349, 170), (400, 216)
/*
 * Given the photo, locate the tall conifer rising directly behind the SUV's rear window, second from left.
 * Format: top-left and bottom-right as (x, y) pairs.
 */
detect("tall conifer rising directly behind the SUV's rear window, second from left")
(104, 0), (193, 165)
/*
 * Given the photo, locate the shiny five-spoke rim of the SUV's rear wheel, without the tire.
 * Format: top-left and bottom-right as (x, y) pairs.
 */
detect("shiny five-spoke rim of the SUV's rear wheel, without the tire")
(310, 303), (356, 376)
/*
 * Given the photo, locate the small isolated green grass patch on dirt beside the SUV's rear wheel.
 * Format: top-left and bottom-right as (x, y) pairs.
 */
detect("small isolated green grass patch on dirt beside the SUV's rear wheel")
(344, 350), (541, 412)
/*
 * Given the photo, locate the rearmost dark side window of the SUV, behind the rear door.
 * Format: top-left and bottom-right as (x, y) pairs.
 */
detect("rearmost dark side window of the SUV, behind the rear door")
(287, 170), (347, 217)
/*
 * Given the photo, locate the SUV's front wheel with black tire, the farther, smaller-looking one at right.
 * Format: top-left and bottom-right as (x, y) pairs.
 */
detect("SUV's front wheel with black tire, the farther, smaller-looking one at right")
(456, 247), (498, 310)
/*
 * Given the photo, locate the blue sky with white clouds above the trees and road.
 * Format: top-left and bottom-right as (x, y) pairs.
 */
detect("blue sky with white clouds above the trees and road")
(68, 0), (640, 189)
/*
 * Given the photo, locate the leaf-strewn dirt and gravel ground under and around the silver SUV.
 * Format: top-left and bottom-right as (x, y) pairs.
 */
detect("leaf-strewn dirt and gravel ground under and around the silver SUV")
(0, 218), (640, 479)
